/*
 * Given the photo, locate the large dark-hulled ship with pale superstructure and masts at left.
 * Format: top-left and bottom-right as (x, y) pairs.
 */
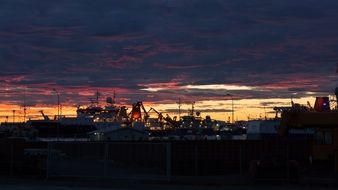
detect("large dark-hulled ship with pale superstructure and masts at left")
(16, 92), (144, 139)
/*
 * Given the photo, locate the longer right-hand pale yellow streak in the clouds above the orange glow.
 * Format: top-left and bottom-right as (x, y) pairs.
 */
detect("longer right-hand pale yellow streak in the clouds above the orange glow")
(182, 84), (254, 90)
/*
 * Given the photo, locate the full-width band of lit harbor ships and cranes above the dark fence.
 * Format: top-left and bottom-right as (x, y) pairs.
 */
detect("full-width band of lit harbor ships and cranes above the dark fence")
(0, 89), (338, 141)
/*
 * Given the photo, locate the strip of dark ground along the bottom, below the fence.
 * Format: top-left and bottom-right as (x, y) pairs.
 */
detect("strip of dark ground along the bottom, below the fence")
(0, 178), (337, 190)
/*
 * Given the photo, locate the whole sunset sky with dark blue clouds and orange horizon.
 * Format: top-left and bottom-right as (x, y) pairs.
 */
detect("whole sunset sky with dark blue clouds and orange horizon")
(0, 0), (338, 121)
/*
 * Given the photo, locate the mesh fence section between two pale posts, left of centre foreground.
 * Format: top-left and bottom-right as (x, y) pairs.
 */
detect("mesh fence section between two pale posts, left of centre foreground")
(47, 142), (170, 179)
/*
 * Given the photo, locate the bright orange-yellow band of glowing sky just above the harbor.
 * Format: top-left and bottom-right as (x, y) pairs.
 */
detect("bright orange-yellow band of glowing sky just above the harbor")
(0, 96), (315, 122)
